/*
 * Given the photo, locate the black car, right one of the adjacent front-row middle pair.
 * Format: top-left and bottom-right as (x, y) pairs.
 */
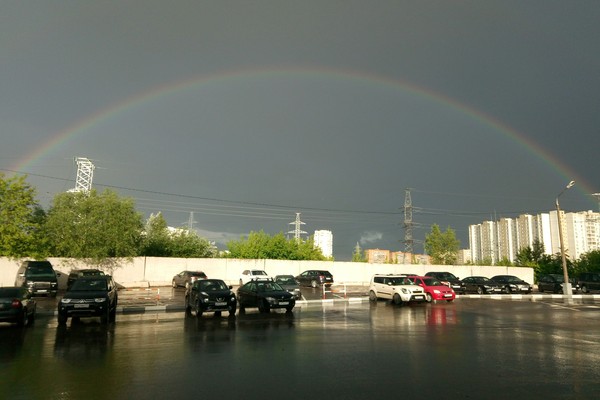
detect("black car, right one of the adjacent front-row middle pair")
(237, 279), (296, 313)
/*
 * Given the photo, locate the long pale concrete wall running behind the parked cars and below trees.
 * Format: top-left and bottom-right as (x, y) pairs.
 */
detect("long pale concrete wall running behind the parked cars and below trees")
(0, 257), (533, 288)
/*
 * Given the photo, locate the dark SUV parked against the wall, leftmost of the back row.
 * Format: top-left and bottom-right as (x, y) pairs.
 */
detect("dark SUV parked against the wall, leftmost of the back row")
(15, 261), (58, 297)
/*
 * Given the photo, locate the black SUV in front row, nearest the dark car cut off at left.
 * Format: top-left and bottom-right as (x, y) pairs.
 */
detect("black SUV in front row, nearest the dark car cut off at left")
(58, 275), (118, 325)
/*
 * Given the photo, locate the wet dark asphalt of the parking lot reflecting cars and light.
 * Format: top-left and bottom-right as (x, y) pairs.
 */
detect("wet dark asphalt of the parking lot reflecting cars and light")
(0, 298), (600, 399)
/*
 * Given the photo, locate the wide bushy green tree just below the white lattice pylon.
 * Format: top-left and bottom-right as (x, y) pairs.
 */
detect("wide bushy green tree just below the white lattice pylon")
(45, 190), (142, 263)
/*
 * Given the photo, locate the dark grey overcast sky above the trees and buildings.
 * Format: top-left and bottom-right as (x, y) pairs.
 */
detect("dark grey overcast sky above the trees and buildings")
(0, 0), (600, 260)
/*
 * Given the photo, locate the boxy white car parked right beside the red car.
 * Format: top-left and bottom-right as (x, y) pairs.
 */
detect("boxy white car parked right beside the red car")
(369, 274), (427, 304)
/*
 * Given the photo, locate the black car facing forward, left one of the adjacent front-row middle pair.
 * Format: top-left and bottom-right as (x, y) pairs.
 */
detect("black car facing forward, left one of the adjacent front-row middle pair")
(185, 279), (237, 317)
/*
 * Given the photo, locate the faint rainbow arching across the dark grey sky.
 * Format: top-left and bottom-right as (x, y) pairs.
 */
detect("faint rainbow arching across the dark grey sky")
(11, 67), (594, 198)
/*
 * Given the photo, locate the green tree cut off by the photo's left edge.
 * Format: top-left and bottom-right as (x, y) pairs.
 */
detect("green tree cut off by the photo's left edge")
(0, 173), (44, 258)
